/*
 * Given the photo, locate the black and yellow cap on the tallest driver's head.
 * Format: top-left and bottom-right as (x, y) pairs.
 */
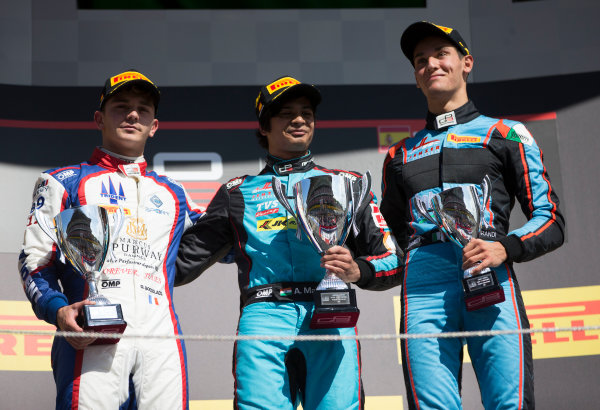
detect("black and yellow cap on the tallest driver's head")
(400, 21), (471, 65)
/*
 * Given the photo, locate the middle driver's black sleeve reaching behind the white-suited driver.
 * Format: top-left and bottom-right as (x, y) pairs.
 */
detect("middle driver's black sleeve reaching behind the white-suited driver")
(175, 185), (233, 286)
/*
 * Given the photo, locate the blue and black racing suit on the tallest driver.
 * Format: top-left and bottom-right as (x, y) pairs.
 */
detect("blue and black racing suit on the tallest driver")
(381, 101), (565, 408)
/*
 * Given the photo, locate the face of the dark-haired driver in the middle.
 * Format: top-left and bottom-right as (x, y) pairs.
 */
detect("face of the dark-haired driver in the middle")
(260, 97), (315, 159)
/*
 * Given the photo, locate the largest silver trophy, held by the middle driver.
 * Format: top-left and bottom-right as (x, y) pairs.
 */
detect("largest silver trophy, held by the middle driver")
(272, 171), (371, 329)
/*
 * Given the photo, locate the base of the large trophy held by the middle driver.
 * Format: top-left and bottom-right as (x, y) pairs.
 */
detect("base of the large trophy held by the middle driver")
(310, 288), (360, 329)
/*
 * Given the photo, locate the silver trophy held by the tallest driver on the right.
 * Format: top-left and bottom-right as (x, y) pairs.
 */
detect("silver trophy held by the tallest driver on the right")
(416, 175), (504, 311)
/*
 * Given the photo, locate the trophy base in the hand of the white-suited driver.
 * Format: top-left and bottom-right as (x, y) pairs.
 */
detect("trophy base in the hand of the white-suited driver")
(81, 304), (127, 345)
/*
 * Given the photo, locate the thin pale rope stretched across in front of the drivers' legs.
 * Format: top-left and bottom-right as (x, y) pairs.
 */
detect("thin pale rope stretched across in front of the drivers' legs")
(0, 325), (600, 342)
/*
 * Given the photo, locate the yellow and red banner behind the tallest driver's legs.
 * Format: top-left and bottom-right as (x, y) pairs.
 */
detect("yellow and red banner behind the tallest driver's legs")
(394, 286), (600, 363)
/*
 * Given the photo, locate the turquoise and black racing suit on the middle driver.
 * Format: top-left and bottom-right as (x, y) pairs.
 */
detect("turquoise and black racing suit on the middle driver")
(176, 154), (402, 409)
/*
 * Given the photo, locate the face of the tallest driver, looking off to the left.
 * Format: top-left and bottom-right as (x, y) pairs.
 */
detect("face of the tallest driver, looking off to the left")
(413, 37), (473, 114)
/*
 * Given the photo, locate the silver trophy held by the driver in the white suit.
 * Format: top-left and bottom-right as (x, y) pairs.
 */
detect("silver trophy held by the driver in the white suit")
(35, 205), (127, 344)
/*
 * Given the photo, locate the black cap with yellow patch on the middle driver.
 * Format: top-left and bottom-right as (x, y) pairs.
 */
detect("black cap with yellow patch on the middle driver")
(254, 76), (321, 120)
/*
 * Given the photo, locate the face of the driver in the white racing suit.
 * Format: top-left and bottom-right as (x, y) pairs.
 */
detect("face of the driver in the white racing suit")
(94, 89), (158, 157)
